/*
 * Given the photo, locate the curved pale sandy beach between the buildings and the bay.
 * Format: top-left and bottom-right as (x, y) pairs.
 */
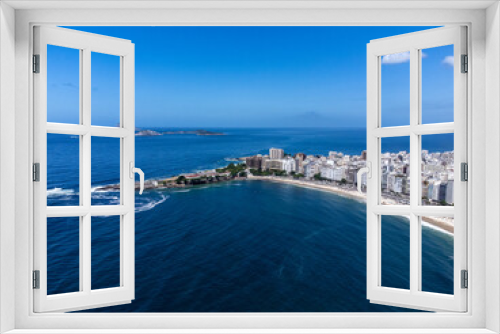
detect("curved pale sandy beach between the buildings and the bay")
(247, 175), (453, 234)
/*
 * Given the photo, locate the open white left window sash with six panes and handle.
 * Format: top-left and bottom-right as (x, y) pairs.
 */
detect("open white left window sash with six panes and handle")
(33, 26), (135, 313)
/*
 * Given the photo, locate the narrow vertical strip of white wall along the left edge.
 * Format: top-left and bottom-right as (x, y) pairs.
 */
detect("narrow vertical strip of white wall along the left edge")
(0, 3), (15, 333)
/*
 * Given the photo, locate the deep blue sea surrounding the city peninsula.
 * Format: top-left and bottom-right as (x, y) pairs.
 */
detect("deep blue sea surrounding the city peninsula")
(47, 129), (453, 312)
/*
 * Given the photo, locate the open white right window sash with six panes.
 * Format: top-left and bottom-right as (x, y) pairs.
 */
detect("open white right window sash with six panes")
(367, 26), (468, 312)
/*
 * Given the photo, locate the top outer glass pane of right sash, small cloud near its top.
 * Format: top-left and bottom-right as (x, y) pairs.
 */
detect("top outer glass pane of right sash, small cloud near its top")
(421, 45), (454, 124)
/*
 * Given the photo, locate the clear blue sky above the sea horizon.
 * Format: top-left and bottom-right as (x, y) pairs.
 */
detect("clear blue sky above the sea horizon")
(48, 27), (453, 128)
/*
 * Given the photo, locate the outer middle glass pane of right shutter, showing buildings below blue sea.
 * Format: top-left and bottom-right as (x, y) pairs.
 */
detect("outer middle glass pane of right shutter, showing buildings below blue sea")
(421, 133), (455, 206)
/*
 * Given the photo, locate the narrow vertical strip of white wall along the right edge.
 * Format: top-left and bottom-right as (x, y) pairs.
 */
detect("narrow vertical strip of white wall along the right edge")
(485, 3), (500, 333)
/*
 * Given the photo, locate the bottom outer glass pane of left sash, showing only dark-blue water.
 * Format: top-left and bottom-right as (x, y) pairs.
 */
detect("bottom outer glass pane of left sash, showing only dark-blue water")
(47, 217), (80, 295)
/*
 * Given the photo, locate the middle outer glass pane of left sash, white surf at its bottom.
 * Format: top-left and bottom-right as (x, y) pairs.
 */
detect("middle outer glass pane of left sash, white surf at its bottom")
(47, 133), (80, 206)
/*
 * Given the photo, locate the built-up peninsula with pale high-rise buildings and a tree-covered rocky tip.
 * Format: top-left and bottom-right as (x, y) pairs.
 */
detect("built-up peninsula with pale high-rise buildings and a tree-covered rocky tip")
(97, 148), (454, 233)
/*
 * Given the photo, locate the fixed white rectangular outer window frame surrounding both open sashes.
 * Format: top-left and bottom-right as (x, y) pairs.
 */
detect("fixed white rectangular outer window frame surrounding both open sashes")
(0, 1), (500, 333)
